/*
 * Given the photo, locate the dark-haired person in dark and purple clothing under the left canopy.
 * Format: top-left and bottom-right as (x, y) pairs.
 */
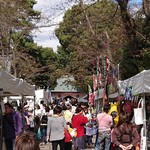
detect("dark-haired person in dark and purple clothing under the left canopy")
(2, 103), (23, 150)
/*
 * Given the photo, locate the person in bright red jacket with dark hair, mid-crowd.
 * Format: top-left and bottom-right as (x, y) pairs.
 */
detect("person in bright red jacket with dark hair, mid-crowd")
(72, 106), (88, 150)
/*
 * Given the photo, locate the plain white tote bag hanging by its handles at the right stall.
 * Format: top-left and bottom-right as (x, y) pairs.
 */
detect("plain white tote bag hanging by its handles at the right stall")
(134, 98), (143, 125)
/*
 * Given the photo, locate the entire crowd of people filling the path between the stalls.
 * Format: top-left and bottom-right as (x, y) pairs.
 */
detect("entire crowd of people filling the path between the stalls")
(2, 98), (140, 150)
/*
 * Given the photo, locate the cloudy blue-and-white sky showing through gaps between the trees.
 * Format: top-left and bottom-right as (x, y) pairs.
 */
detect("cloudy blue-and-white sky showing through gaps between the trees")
(33, 0), (142, 51)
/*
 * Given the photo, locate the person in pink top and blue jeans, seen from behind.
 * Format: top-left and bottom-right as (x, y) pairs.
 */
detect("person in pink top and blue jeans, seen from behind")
(95, 105), (113, 150)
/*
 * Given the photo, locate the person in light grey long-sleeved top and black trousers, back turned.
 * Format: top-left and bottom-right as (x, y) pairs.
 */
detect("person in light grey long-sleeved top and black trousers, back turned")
(47, 106), (67, 150)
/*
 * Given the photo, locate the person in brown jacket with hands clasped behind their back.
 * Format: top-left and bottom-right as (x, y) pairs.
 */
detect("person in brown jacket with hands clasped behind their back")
(112, 113), (140, 150)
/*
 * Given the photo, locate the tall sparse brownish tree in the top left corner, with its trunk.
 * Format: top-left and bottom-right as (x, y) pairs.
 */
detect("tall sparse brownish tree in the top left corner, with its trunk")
(0, 0), (40, 77)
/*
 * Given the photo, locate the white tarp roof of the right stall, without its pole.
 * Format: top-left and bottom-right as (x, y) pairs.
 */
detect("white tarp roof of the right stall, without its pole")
(118, 70), (150, 95)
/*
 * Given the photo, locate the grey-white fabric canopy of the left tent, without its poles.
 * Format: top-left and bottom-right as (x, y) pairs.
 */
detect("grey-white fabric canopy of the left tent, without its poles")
(0, 69), (35, 96)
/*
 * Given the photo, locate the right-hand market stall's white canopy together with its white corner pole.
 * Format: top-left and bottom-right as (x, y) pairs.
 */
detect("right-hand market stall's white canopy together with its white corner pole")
(118, 70), (150, 150)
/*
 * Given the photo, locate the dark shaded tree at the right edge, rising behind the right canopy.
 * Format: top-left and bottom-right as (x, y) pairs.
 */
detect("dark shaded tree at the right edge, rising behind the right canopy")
(117, 0), (150, 79)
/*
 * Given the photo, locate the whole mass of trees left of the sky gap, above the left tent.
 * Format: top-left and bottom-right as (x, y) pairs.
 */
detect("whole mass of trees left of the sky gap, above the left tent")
(0, 0), (59, 88)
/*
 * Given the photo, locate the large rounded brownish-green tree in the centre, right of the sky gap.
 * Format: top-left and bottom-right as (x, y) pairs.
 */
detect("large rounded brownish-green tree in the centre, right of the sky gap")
(56, 1), (124, 90)
